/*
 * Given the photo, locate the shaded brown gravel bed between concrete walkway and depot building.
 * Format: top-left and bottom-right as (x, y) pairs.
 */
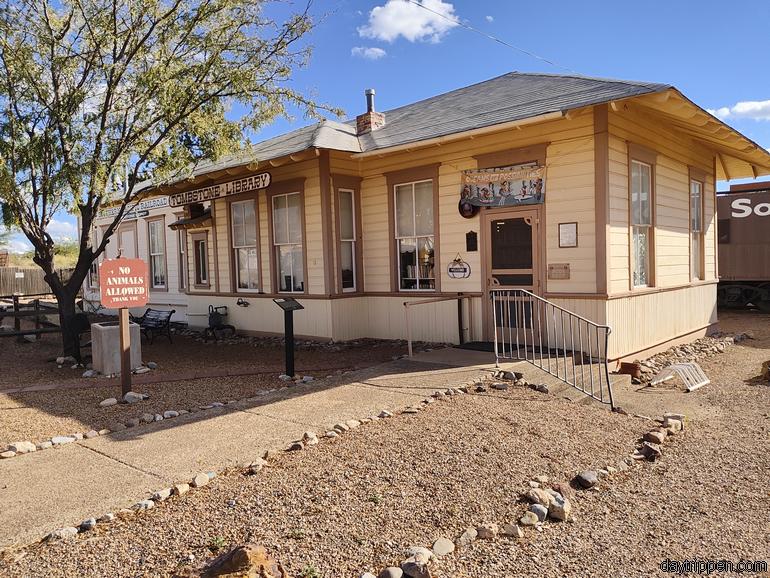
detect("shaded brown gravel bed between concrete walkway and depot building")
(0, 336), (420, 449)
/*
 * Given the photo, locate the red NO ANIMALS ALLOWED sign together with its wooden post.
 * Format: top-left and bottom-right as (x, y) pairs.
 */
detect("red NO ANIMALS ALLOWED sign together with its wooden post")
(99, 258), (148, 396)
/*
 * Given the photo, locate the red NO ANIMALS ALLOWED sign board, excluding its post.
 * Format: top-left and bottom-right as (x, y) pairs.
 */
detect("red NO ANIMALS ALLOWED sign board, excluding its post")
(99, 259), (149, 309)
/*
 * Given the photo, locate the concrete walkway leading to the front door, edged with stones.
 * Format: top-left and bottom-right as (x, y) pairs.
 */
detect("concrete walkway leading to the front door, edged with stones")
(0, 350), (493, 547)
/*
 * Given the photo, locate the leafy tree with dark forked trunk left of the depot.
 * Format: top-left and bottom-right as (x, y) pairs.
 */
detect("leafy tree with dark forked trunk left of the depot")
(0, 0), (337, 353)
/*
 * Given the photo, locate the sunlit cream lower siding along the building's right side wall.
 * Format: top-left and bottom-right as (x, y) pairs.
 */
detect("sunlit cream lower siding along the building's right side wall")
(607, 284), (717, 358)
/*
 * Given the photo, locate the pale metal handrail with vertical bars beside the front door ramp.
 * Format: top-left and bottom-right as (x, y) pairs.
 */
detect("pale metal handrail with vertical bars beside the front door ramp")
(490, 289), (615, 408)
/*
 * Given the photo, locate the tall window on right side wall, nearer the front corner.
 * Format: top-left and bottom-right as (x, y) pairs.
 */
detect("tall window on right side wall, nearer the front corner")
(631, 160), (652, 287)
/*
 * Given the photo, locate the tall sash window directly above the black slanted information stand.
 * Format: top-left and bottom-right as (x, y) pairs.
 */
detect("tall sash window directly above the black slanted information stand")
(273, 193), (305, 293)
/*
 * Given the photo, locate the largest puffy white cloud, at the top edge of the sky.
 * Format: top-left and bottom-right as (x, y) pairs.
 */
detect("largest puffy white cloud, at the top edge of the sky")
(358, 0), (460, 42)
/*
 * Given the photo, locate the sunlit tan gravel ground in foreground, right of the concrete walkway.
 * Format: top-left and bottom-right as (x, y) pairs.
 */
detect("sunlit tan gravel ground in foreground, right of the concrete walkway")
(0, 315), (770, 578)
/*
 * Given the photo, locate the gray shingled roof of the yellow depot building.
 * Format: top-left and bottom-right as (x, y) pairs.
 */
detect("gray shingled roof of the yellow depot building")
(153, 72), (671, 184)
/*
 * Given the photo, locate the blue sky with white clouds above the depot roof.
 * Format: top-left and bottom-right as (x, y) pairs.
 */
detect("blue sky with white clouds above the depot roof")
(6, 0), (770, 248)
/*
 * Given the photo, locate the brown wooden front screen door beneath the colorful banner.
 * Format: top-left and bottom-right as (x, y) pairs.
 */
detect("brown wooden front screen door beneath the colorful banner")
(483, 208), (540, 340)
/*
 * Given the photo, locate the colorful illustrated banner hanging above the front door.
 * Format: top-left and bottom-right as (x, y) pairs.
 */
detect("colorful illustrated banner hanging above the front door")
(460, 167), (545, 207)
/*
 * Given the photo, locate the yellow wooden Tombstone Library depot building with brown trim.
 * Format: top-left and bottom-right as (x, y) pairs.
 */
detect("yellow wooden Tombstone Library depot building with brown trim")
(85, 73), (770, 359)
